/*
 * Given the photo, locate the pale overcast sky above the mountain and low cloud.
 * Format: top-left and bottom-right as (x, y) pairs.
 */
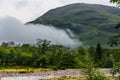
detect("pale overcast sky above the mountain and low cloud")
(0, 0), (114, 23)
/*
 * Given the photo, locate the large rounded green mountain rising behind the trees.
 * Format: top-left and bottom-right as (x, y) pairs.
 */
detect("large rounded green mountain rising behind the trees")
(28, 3), (120, 46)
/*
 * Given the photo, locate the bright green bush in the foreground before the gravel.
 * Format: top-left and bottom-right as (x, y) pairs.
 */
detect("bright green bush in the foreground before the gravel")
(82, 56), (107, 80)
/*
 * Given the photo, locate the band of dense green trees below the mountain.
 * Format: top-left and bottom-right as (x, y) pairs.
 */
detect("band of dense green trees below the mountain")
(0, 39), (120, 69)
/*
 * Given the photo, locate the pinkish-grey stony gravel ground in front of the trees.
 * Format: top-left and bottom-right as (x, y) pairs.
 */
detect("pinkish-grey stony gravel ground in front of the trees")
(0, 69), (111, 80)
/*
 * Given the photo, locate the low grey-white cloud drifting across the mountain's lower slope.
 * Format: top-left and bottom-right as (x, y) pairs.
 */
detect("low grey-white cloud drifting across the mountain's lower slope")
(0, 17), (82, 47)
